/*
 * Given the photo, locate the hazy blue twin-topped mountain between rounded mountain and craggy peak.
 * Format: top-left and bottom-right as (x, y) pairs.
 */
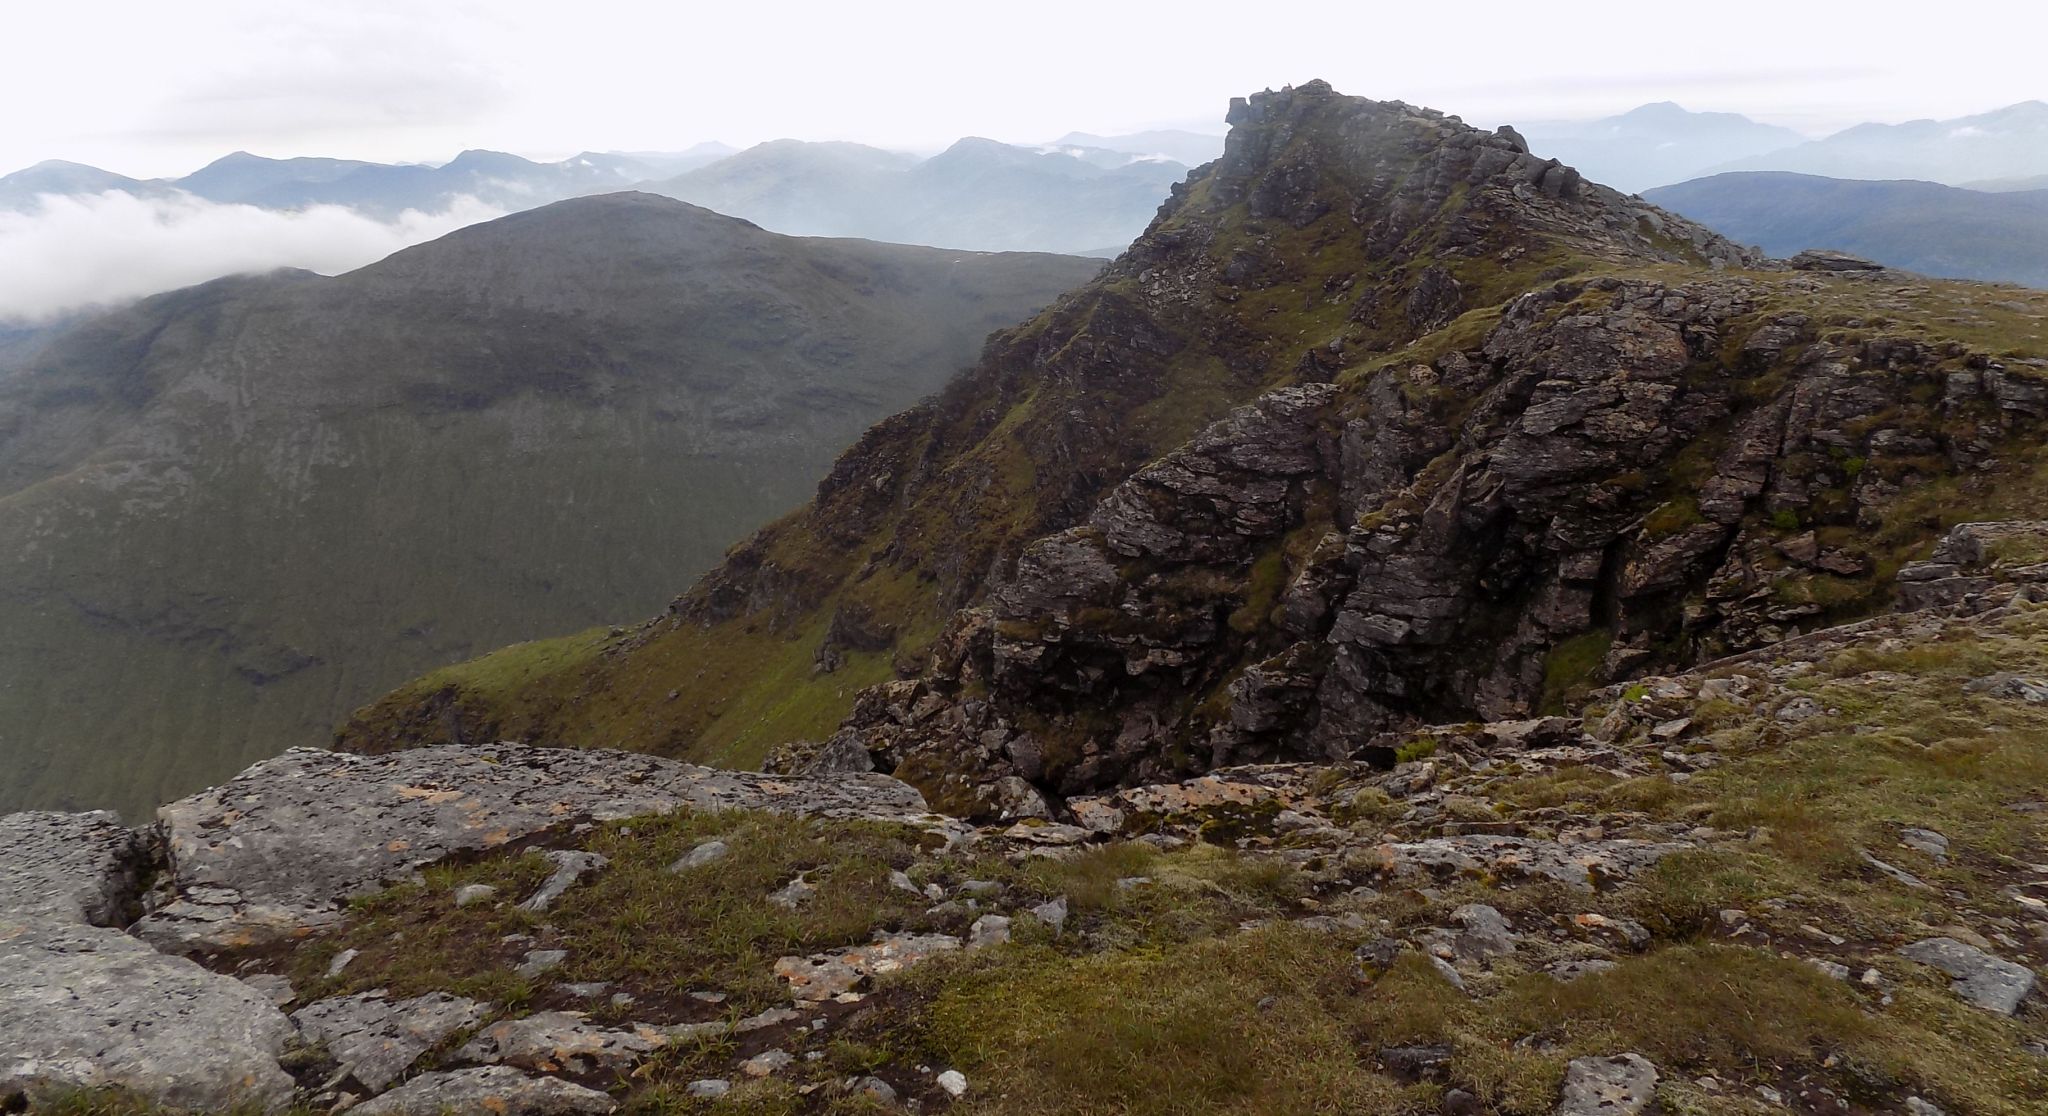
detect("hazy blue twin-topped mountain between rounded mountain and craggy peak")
(645, 137), (1188, 252)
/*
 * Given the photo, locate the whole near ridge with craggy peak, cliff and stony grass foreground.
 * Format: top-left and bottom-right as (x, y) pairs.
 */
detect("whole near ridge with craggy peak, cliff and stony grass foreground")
(0, 82), (2048, 1116)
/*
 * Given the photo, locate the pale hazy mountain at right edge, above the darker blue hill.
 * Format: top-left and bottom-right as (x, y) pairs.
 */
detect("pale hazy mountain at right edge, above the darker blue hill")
(1714, 100), (2048, 184)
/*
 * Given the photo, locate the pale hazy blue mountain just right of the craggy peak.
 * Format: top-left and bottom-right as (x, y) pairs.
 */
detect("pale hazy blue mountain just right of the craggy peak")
(1522, 100), (1804, 190)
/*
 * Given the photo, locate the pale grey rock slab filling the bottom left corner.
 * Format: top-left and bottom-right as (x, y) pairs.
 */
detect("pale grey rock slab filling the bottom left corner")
(0, 917), (293, 1112)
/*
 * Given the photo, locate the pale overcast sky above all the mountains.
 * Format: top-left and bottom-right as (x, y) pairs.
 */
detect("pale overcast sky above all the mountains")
(0, 0), (2048, 176)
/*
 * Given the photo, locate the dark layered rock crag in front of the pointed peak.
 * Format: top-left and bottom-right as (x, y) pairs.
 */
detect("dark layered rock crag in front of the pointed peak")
(815, 278), (2048, 817)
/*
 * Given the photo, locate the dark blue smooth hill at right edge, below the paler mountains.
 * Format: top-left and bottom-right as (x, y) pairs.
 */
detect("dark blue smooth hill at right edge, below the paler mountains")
(1642, 172), (2048, 287)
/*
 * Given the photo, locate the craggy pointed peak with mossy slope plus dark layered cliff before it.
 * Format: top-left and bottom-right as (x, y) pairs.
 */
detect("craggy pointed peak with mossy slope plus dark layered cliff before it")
(344, 82), (2040, 811)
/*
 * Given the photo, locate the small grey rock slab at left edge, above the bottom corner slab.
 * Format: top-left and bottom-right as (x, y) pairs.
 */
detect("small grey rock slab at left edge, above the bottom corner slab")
(0, 811), (150, 926)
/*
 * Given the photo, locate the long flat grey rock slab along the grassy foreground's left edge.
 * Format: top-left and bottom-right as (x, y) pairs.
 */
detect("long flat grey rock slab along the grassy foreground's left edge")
(135, 743), (938, 950)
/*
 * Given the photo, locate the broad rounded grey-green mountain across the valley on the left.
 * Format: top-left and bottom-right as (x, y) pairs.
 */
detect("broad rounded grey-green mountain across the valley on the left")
(0, 195), (1100, 809)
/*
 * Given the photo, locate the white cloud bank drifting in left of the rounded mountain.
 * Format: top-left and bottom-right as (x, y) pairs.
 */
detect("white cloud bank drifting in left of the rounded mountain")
(0, 190), (504, 321)
